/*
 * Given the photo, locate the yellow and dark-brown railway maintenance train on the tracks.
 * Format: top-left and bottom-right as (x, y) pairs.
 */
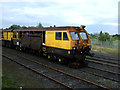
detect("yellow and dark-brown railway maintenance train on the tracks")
(2, 25), (92, 67)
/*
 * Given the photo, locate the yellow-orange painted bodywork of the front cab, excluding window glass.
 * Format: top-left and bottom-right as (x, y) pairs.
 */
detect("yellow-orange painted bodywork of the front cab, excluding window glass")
(45, 28), (91, 50)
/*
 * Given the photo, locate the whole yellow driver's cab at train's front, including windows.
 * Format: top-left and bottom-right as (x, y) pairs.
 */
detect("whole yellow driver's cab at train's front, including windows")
(46, 26), (90, 50)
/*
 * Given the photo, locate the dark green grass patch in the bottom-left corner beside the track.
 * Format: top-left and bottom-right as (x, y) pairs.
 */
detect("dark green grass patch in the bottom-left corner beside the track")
(2, 75), (20, 90)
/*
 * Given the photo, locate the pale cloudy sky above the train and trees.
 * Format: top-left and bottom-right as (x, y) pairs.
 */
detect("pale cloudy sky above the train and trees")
(0, 0), (119, 34)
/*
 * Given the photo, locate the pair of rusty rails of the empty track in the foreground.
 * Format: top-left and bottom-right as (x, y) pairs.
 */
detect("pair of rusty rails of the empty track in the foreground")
(3, 52), (108, 89)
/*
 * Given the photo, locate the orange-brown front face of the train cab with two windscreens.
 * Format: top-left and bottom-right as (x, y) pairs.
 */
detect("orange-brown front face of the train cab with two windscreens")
(69, 28), (91, 50)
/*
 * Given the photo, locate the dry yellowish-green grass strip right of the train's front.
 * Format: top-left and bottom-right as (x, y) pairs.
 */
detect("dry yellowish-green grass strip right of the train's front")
(92, 45), (120, 56)
